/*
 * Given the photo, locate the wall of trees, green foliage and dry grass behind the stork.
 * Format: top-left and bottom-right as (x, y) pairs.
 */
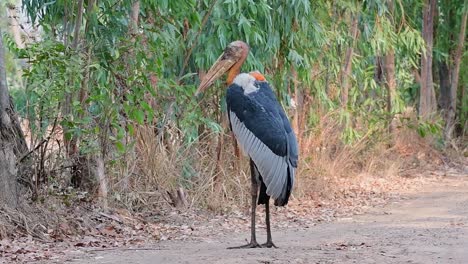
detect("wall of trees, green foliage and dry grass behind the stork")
(0, 0), (468, 210)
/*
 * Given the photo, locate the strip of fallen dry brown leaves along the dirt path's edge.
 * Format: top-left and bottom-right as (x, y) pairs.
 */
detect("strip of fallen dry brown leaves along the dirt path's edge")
(0, 168), (452, 263)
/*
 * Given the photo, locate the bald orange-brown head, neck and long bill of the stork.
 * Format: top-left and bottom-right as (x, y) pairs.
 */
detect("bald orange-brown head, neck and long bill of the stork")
(195, 40), (249, 96)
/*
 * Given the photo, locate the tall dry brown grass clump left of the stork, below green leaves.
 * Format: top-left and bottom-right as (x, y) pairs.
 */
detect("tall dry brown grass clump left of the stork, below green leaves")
(107, 126), (249, 211)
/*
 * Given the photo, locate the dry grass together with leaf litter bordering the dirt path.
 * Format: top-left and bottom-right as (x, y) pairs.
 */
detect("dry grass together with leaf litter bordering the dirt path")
(0, 110), (463, 261)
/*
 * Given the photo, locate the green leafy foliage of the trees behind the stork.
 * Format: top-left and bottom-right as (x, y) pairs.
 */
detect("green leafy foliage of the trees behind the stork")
(7, 0), (468, 173)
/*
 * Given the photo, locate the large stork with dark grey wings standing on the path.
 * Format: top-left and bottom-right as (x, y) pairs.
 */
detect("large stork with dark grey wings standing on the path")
(196, 41), (298, 248)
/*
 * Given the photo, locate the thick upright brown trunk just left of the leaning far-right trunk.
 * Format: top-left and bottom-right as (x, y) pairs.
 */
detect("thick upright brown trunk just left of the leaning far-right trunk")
(419, 0), (437, 119)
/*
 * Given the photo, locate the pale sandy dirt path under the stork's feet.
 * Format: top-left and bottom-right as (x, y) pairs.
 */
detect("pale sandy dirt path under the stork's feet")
(66, 177), (468, 264)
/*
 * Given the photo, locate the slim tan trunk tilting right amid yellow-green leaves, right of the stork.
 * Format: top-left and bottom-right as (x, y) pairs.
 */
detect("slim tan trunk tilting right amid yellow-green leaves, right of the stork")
(340, 14), (358, 107)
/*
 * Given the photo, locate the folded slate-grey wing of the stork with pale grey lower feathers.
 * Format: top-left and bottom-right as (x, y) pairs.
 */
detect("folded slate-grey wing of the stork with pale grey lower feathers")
(226, 82), (297, 201)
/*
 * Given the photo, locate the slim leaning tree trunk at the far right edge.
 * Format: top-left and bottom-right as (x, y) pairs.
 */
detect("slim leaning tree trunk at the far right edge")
(445, 4), (468, 140)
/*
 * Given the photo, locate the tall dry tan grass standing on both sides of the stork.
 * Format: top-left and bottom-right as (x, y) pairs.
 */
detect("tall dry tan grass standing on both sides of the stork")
(105, 110), (437, 212)
